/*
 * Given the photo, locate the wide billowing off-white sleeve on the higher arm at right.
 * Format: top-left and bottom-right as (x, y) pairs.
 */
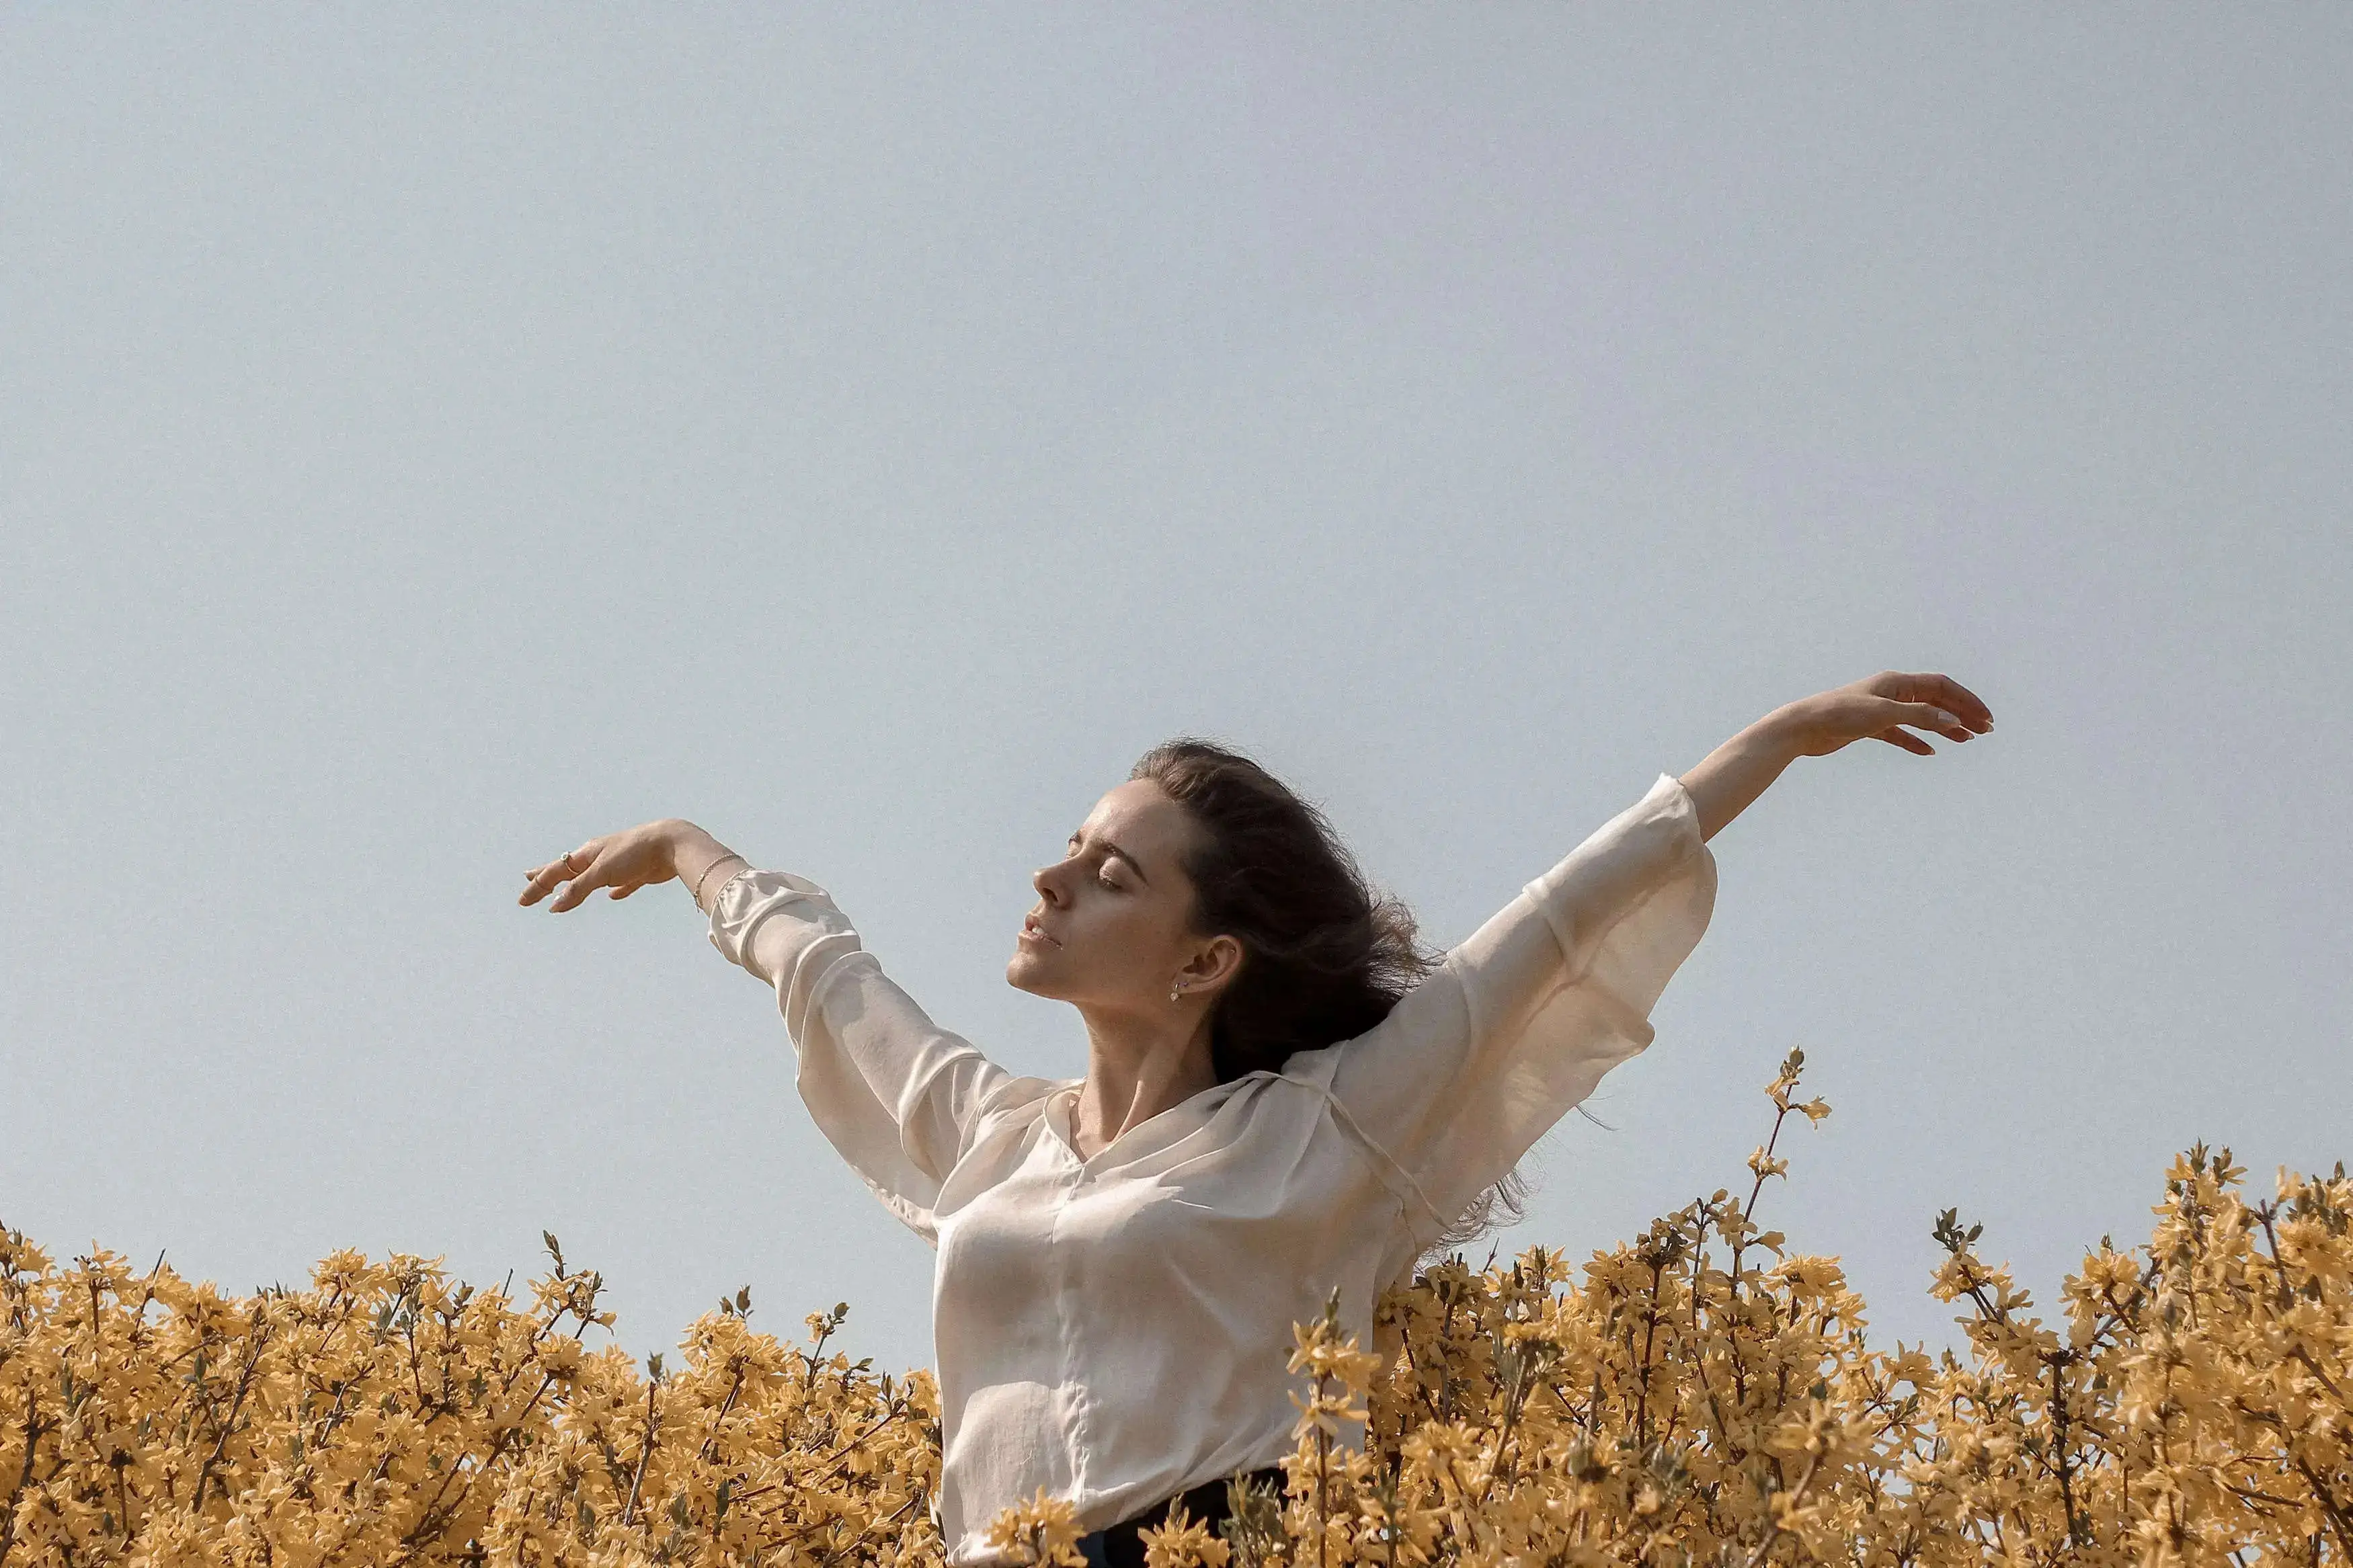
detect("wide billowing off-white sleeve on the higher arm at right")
(1332, 774), (1716, 1246)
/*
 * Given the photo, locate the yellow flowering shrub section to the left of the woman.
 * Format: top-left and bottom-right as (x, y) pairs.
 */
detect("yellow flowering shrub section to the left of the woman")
(0, 1232), (939, 1568)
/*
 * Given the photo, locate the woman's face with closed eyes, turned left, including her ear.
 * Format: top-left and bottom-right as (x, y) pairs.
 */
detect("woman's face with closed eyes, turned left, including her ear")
(1005, 778), (1240, 1016)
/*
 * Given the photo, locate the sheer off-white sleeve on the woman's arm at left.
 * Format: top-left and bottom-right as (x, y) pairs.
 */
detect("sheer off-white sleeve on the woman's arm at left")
(711, 870), (1007, 1246)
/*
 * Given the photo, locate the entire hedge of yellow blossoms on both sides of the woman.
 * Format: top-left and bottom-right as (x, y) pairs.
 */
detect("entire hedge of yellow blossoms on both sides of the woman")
(0, 1053), (2353, 1568)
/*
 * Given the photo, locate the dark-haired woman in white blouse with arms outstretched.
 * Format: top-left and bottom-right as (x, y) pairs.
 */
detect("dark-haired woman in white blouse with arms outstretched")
(522, 672), (1993, 1566)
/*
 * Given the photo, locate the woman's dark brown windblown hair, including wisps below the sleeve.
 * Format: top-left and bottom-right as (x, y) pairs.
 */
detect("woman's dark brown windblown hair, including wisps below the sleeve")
(1127, 736), (1525, 1246)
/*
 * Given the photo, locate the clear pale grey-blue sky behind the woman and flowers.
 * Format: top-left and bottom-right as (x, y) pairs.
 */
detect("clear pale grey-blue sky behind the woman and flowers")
(0, 5), (2353, 1366)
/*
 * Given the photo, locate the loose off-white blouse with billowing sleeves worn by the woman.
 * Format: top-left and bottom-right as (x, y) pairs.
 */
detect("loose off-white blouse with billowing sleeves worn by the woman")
(711, 776), (1716, 1568)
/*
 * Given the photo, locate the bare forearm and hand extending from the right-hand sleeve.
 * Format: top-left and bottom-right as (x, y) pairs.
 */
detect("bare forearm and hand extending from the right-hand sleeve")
(1683, 670), (1993, 839)
